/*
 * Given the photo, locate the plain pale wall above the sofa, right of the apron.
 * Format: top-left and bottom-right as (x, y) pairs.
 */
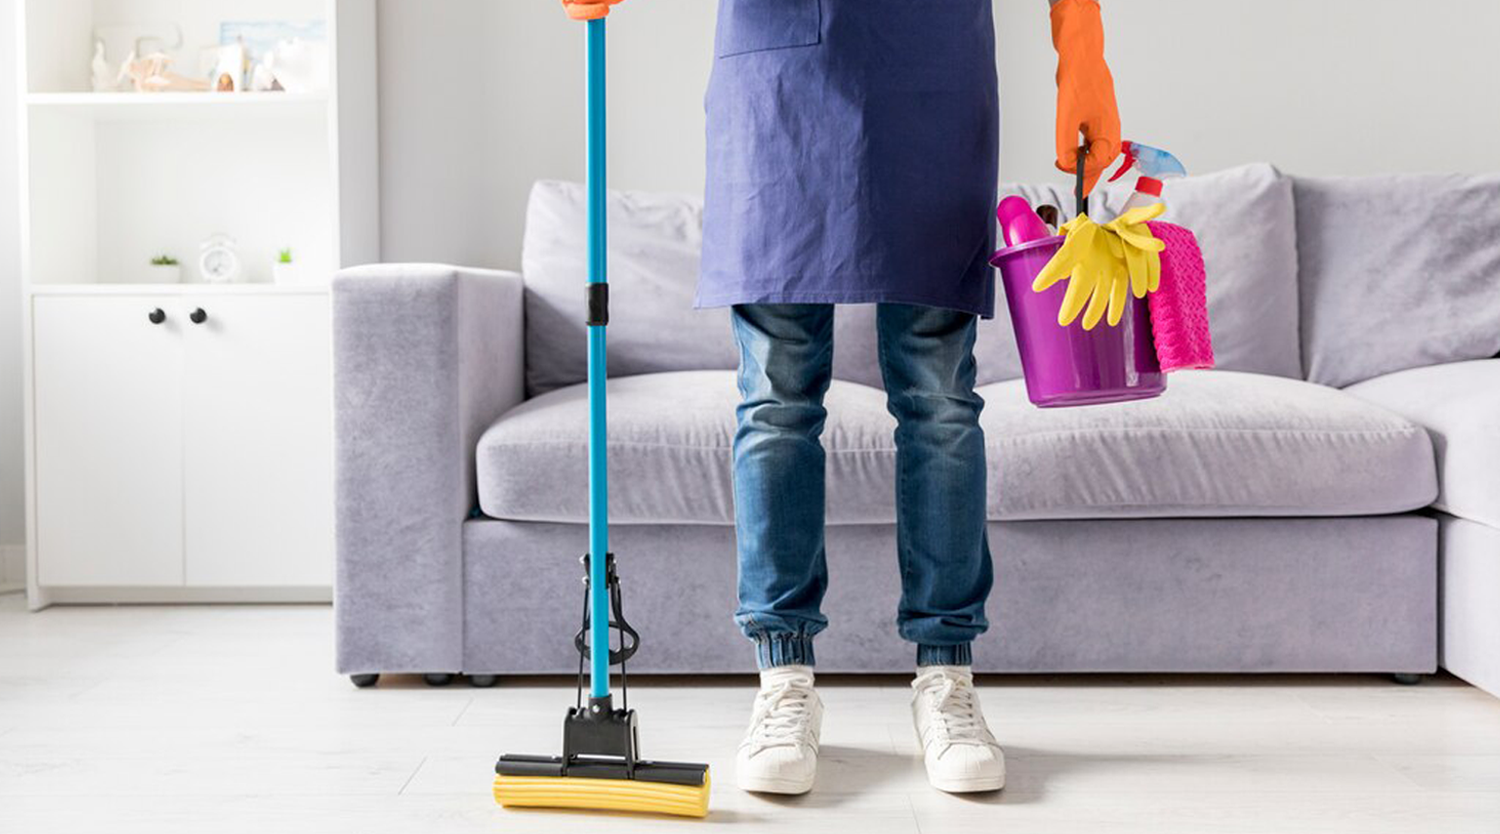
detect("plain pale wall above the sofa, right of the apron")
(996, 0), (1500, 180)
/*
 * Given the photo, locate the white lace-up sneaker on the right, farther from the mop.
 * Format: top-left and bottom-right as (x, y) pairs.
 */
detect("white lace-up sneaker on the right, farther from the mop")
(912, 666), (1005, 794)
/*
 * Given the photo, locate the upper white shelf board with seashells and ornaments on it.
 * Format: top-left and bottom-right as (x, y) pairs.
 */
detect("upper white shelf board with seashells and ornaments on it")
(26, 93), (329, 122)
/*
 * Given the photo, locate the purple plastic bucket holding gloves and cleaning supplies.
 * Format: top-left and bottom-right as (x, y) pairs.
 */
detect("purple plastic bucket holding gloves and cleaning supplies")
(990, 236), (1167, 408)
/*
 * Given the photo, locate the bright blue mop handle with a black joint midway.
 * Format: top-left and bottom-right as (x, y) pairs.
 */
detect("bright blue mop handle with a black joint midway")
(588, 20), (609, 698)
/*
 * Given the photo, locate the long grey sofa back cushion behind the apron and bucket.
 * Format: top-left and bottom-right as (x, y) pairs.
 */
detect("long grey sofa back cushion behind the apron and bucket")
(522, 165), (1302, 396)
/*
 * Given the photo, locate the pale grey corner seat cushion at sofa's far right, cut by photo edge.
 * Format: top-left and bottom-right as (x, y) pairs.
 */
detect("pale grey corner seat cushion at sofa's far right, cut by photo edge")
(1346, 359), (1500, 528)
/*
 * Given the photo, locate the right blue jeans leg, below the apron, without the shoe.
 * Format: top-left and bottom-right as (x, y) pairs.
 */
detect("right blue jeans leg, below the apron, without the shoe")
(878, 305), (995, 666)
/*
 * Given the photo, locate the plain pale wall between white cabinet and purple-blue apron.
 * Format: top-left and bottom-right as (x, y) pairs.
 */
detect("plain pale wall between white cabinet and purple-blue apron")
(380, 0), (720, 267)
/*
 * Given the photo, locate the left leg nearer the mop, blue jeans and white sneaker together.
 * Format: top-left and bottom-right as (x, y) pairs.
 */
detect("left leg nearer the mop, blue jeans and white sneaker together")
(734, 305), (834, 794)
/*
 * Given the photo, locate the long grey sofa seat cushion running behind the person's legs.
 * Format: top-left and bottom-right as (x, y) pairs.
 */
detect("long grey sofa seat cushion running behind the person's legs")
(477, 371), (1437, 525)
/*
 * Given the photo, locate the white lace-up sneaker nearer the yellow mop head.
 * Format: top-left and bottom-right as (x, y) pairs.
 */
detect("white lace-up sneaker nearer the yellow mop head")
(735, 666), (824, 794)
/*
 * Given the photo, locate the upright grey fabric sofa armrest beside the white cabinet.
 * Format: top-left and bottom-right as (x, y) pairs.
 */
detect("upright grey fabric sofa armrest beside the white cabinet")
(333, 266), (525, 674)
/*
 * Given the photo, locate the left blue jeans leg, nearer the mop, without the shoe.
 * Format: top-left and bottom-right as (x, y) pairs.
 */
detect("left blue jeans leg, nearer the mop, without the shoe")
(734, 305), (834, 669)
